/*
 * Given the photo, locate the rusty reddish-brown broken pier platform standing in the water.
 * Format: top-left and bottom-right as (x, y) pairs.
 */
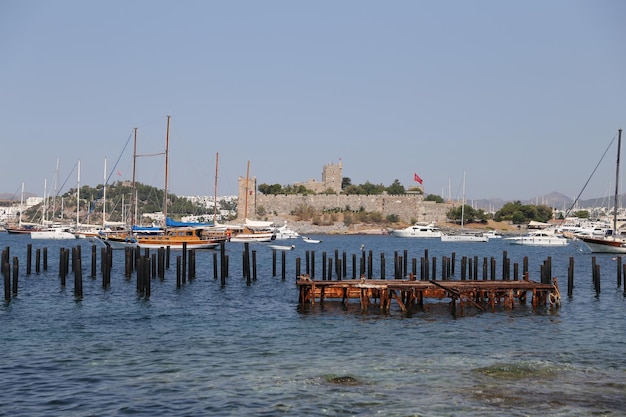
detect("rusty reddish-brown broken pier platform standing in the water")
(296, 275), (561, 312)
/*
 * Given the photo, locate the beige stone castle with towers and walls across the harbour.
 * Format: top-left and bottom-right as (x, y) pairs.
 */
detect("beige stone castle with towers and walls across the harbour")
(237, 162), (452, 223)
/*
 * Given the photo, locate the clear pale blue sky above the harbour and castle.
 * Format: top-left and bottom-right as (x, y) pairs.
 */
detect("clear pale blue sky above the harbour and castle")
(0, 0), (626, 201)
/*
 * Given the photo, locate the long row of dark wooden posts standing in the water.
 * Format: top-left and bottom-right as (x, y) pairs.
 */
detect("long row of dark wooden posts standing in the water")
(1, 243), (626, 300)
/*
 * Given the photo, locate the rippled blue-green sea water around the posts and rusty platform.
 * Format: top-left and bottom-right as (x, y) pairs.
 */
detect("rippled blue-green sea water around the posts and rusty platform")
(0, 233), (626, 416)
